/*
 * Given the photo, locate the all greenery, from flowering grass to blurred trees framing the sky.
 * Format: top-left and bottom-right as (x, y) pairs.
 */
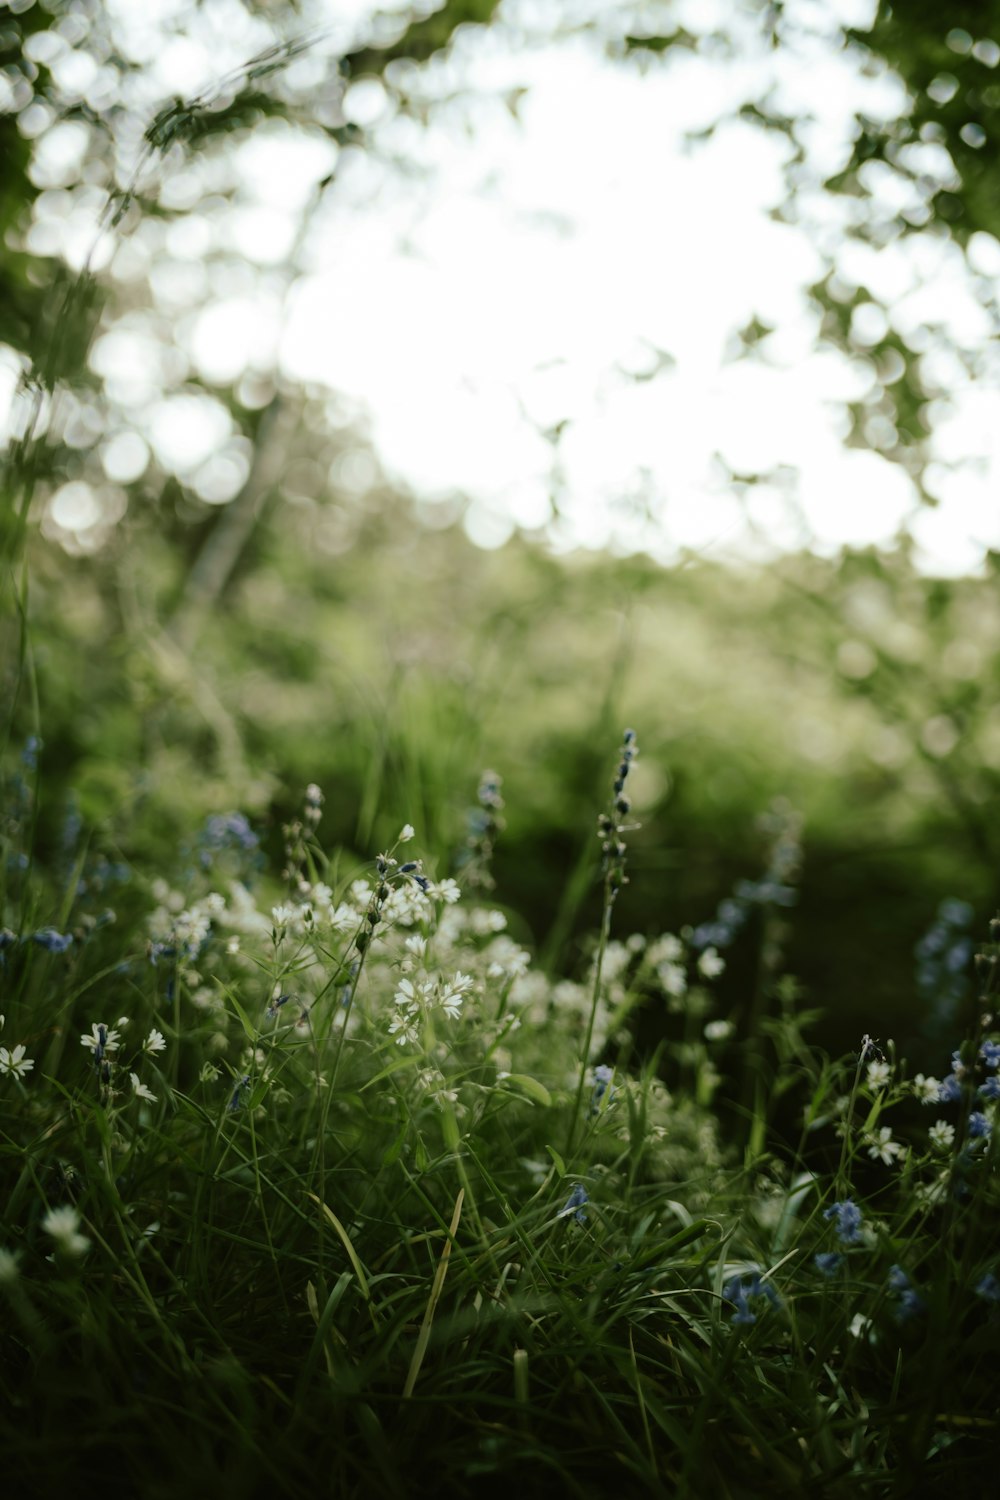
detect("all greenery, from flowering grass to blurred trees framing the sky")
(0, 0), (1000, 1500)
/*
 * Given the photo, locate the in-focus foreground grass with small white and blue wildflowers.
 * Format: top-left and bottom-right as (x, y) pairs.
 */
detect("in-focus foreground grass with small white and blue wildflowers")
(0, 729), (1000, 1496)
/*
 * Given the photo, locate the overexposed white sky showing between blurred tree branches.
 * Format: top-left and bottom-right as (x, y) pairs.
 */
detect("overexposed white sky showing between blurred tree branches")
(0, 0), (1000, 573)
